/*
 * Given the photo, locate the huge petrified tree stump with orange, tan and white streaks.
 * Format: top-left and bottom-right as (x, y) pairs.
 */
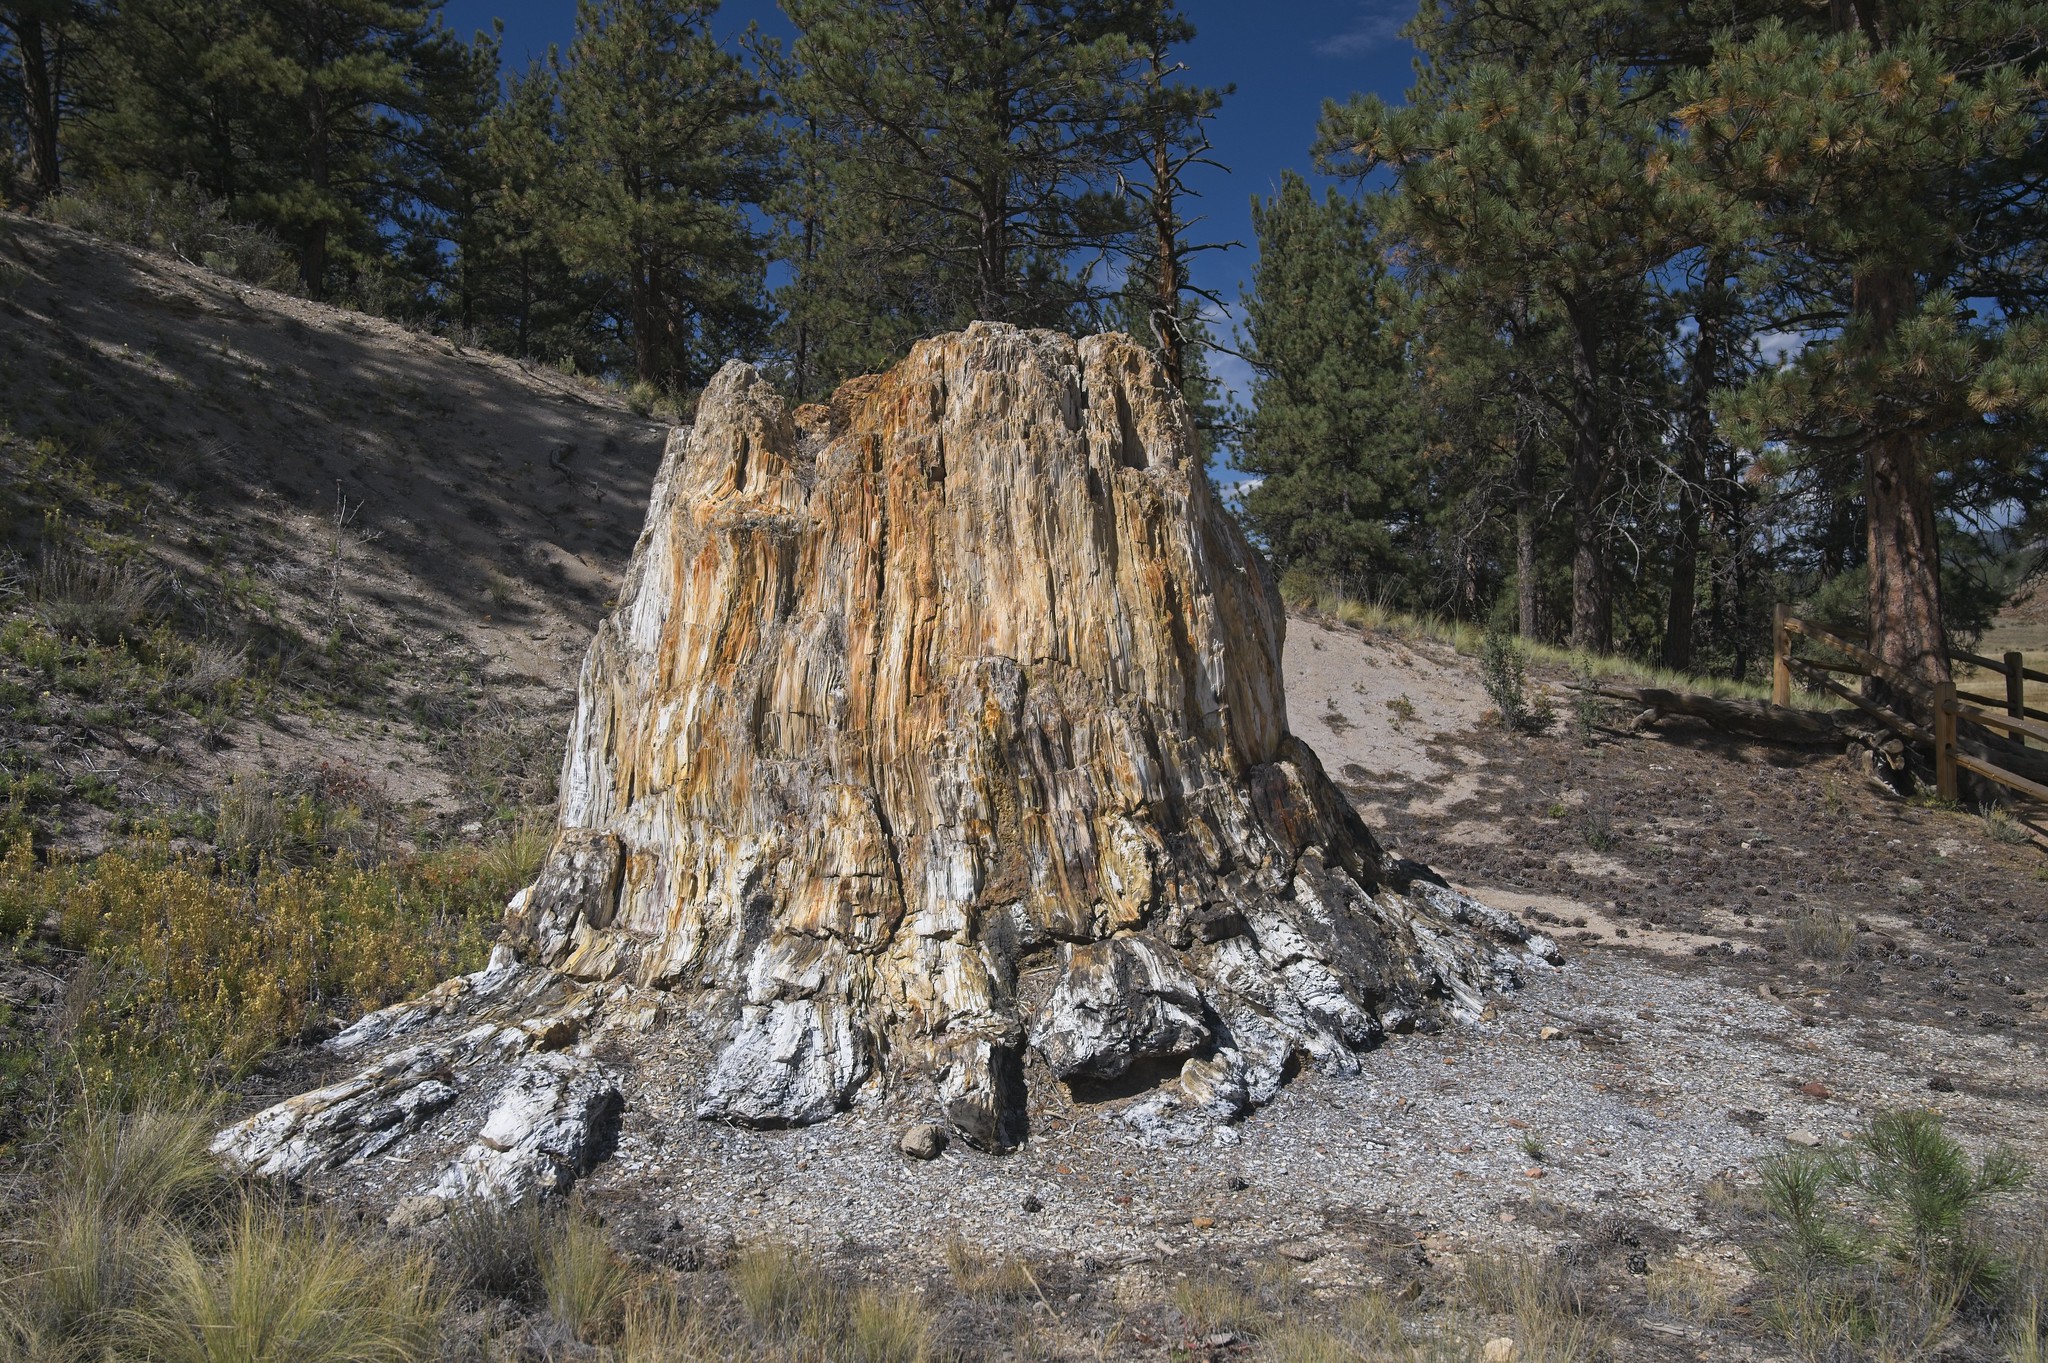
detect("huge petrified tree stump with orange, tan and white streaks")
(221, 323), (1550, 1195)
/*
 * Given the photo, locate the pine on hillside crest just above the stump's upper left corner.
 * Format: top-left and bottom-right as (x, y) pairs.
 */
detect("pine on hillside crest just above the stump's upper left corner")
(547, 0), (780, 391)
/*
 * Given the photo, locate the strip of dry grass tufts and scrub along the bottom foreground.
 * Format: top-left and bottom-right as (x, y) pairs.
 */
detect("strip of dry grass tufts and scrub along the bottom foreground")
(0, 1101), (2048, 1363)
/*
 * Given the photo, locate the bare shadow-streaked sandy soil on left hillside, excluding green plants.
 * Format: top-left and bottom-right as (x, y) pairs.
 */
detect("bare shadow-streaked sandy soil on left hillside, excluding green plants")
(0, 215), (668, 825)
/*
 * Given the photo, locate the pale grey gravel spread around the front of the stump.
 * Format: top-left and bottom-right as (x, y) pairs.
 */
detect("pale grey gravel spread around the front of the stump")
(584, 933), (2044, 1269)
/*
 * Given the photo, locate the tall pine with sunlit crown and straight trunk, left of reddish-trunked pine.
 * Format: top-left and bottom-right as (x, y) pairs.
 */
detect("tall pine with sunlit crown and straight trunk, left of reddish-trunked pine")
(1317, 21), (1688, 653)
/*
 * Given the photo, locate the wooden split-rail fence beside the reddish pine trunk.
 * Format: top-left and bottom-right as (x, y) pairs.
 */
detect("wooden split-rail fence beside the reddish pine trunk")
(1772, 606), (2048, 802)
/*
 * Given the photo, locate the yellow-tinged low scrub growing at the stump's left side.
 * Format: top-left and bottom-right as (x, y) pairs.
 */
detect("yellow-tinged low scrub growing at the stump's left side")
(0, 782), (543, 1142)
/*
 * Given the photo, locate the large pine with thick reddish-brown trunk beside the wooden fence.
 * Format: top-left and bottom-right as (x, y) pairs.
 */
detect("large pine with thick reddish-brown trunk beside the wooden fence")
(1677, 0), (2048, 682)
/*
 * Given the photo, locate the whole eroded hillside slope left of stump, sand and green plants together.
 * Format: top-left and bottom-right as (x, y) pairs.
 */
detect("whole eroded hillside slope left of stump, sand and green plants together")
(0, 215), (666, 847)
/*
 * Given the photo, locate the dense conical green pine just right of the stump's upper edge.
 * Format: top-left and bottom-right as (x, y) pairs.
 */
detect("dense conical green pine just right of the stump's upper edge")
(1235, 174), (1421, 602)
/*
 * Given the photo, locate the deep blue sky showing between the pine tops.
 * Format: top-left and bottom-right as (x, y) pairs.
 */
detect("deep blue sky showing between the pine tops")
(432, 0), (1415, 409)
